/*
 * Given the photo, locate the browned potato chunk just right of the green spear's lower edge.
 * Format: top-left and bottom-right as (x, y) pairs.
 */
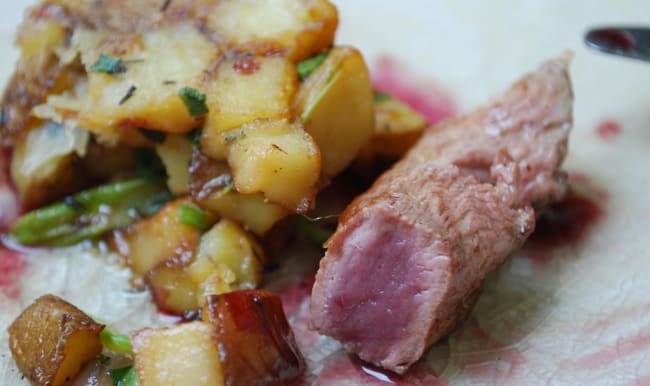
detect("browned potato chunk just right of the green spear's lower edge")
(113, 198), (208, 277)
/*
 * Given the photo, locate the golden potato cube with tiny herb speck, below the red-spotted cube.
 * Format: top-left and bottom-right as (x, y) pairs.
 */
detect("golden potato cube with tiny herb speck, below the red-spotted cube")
(222, 120), (321, 213)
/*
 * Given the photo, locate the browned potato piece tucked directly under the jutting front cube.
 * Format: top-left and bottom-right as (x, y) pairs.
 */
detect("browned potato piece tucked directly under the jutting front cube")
(190, 151), (289, 236)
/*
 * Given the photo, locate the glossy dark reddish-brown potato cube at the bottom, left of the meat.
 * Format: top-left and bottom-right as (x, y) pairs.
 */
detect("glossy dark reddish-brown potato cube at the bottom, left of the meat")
(202, 290), (305, 386)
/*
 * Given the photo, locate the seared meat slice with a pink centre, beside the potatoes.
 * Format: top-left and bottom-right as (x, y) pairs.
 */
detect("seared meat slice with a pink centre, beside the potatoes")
(311, 57), (573, 373)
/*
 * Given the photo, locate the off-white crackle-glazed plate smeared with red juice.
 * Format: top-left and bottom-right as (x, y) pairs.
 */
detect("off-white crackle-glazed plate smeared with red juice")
(0, 0), (650, 385)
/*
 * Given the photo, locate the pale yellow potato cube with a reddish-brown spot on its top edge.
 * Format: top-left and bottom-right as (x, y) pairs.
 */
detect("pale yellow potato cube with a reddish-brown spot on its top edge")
(201, 56), (298, 159)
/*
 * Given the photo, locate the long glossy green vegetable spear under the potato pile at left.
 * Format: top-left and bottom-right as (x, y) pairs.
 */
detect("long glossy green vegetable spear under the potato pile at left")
(9, 179), (170, 246)
